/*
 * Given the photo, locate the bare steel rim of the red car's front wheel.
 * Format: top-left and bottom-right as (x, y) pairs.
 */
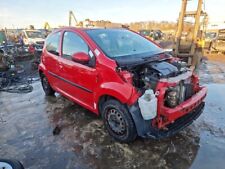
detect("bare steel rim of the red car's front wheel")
(107, 109), (126, 135)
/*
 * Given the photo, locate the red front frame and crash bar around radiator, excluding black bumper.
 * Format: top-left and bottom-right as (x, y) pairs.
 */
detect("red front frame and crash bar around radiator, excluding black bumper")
(153, 71), (207, 129)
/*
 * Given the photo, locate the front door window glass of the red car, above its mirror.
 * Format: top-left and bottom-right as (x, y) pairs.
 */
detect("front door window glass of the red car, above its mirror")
(62, 32), (89, 60)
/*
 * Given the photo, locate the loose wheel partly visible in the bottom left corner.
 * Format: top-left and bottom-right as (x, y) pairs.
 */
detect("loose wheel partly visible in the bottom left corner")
(0, 159), (24, 169)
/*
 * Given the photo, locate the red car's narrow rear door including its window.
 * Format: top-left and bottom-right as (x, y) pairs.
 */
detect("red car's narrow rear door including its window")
(42, 32), (61, 89)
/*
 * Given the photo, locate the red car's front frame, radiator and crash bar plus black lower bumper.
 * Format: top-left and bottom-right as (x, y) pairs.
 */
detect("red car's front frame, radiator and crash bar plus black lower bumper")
(143, 72), (207, 138)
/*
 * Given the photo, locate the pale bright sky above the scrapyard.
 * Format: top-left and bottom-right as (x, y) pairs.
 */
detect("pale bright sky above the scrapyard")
(0, 0), (225, 28)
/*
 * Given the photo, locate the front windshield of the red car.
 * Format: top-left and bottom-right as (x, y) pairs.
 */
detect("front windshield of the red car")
(87, 29), (162, 58)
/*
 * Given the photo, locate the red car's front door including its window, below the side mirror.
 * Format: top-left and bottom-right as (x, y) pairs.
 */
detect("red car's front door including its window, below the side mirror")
(57, 31), (97, 109)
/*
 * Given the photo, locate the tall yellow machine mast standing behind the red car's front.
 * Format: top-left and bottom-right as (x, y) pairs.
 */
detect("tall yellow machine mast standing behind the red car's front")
(173, 0), (208, 70)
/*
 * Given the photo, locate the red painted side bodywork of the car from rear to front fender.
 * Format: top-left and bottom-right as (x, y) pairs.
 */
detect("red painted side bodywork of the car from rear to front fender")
(39, 28), (134, 114)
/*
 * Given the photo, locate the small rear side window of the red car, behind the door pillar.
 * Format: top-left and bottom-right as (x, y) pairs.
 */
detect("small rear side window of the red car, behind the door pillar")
(45, 32), (60, 56)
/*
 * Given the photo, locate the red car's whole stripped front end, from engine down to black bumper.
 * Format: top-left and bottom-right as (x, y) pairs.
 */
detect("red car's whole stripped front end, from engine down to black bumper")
(119, 54), (207, 138)
